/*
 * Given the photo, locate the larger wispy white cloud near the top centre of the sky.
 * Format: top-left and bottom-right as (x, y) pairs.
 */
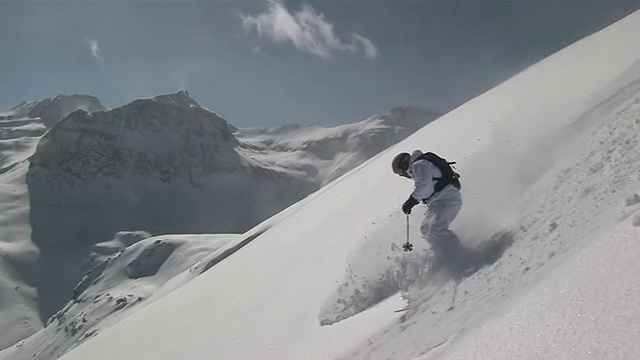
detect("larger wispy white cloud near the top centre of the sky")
(240, 0), (379, 59)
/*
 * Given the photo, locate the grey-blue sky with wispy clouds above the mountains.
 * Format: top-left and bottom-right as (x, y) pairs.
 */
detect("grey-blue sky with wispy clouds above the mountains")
(0, 0), (640, 127)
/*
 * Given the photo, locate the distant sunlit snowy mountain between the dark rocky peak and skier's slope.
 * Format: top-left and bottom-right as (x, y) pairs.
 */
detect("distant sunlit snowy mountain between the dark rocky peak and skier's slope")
(234, 106), (440, 185)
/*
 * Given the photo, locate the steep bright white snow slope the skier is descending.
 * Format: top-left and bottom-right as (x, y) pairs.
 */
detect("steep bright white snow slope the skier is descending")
(48, 13), (640, 359)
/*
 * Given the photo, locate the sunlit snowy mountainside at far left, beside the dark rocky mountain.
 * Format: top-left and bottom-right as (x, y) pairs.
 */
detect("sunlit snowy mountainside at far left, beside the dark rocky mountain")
(0, 95), (105, 349)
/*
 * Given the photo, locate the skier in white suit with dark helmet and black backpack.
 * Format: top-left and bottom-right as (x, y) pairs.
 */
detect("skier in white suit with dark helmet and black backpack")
(391, 150), (462, 263)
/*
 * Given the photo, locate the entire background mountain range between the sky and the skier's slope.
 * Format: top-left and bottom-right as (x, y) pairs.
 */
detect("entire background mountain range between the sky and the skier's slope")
(0, 91), (438, 358)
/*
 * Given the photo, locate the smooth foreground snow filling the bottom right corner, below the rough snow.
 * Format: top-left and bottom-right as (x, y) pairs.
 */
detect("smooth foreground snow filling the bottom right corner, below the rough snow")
(430, 221), (640, 360)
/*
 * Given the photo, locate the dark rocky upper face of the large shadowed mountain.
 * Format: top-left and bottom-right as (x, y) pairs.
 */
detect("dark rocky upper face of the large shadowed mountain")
(31, 92), (240, 186)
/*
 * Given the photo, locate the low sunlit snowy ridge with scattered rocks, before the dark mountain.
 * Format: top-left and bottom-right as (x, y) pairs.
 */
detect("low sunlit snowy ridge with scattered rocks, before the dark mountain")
(0, 232), (238, 359)
